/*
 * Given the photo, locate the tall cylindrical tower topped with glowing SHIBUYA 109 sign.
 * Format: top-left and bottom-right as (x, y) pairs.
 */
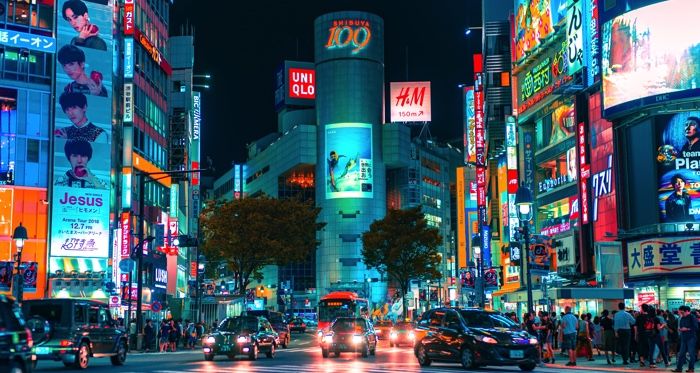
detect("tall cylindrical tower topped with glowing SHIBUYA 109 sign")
(315, 12), (386, 300)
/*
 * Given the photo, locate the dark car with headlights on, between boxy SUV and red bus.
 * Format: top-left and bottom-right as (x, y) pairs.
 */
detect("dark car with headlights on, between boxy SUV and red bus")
(202, 316), (279, 361)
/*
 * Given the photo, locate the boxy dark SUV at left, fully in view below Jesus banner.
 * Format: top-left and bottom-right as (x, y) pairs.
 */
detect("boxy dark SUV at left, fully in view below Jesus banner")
(22, 299), (129, 369)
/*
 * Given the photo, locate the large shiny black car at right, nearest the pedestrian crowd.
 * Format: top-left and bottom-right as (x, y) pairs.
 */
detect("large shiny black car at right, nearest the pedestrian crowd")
(414, 308), (539, 371)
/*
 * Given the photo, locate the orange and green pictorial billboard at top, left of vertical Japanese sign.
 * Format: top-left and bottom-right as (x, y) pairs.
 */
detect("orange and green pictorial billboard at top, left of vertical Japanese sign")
(515, 0), (567, 61)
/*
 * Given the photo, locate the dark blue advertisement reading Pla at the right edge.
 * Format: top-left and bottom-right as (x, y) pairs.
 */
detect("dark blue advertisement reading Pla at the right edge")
(656, 111), (700, 222)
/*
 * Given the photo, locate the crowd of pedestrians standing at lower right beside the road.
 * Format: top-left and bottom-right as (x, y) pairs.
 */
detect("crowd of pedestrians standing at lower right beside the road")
(506, 303), (700, 372)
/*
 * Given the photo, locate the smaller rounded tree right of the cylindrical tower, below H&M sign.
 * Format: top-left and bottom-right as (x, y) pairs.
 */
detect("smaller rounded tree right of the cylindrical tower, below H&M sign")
(362, 206), (442, 318)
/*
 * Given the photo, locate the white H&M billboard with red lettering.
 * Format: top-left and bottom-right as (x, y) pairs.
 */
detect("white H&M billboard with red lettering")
(389, 82), (431, 122)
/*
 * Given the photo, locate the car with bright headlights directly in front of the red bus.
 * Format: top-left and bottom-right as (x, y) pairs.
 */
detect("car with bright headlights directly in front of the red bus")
(320, 317), (378, 358)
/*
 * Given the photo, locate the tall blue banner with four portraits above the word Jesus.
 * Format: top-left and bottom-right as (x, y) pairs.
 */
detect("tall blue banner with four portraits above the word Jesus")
(49, 0), (114, 258)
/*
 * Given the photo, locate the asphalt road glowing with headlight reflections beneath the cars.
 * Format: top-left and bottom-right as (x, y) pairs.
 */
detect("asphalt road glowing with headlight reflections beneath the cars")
(31, 332), (658, 373)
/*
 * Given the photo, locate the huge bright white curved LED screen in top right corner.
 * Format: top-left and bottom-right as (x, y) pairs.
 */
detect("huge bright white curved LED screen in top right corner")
(602, 0), (700, 115)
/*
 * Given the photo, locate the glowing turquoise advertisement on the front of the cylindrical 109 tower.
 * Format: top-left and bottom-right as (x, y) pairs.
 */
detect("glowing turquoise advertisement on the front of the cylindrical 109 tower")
(325, 123), (374, 198)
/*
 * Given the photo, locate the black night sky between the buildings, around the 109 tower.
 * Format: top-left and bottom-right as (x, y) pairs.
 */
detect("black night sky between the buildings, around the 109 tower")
(170, 0), (481, 176)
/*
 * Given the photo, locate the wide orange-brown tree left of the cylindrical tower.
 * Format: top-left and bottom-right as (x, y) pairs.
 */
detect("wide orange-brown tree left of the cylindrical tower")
(200, 196), (325, 295)
